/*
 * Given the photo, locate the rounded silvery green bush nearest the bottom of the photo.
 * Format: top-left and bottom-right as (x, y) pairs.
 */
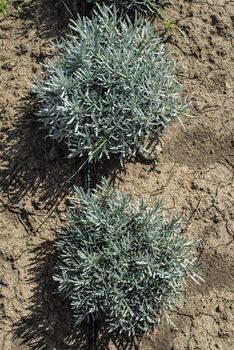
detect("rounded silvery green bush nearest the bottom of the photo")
(54, 181), (199, 336)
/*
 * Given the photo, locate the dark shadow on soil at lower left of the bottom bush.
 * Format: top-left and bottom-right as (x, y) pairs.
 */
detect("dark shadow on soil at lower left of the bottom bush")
(14, 241), (87, 350)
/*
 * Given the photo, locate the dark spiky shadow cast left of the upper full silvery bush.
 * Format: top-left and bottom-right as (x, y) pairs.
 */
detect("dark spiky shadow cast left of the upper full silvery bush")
(0, 97), (82, 214)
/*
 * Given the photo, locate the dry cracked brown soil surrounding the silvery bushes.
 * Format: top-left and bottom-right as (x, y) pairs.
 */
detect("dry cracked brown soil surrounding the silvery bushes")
(0, 0), (234, 350)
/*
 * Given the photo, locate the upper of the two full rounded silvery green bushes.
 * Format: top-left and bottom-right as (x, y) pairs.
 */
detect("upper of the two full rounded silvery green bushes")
(32, 6), (184, 159)
